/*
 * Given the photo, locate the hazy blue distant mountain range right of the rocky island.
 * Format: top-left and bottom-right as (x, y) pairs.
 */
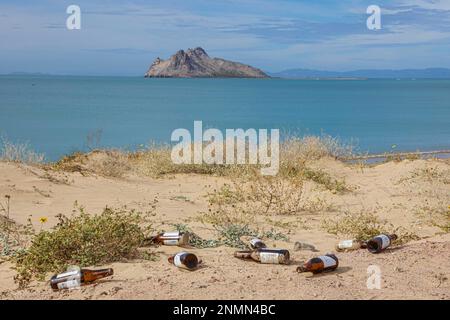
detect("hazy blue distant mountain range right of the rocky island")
(269, 68), (450, 79)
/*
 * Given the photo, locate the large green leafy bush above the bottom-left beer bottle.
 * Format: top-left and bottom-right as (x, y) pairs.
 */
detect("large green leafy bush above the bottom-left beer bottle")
(12, 207), (155, 287)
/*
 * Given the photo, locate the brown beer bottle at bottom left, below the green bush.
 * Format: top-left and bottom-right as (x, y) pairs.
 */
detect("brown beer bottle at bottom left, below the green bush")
(50, 268), (114, 290)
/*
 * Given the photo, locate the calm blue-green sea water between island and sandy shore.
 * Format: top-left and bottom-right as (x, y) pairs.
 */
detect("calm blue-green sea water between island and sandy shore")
(0, 76), (450, 160)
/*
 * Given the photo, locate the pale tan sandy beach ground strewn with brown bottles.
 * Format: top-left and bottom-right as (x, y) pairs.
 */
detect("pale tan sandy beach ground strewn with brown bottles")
(0, 159), (450, 299)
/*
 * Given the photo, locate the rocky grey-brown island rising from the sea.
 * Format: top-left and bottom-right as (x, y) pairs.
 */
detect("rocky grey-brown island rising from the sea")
(145, 47), (269, 78)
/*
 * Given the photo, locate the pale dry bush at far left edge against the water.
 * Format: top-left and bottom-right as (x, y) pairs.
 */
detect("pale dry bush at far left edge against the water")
(0, 137), (44, 164)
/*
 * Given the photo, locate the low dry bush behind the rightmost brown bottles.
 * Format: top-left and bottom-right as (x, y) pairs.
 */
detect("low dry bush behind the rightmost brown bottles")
(322, 211), (419, 244)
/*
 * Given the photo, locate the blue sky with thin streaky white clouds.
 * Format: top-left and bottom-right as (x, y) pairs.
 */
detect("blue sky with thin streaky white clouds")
(0, 0), (450, 76)
